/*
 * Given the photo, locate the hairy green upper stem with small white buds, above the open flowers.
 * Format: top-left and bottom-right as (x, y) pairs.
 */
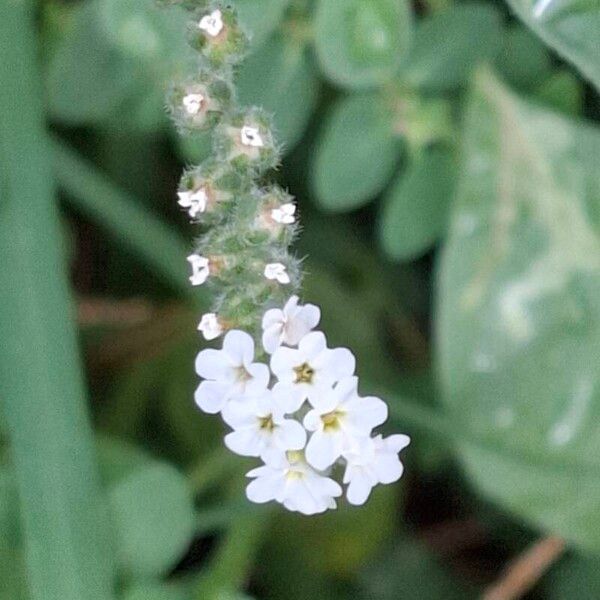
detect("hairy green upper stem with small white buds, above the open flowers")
(168, 2), (301, 340)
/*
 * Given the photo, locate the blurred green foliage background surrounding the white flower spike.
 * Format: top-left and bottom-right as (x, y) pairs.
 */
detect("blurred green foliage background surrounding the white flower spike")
(0, 0), (600, 600)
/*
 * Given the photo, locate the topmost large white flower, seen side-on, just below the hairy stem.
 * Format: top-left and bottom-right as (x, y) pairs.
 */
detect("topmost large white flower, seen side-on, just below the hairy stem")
(262, 296), (321, 354)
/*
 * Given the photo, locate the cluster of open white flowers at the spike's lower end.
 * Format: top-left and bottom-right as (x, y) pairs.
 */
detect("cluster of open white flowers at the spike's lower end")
(195, 296), (410, 514)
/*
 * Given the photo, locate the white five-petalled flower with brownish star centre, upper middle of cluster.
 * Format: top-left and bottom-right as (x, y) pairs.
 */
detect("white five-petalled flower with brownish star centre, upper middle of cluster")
(271, 331), (356, 408)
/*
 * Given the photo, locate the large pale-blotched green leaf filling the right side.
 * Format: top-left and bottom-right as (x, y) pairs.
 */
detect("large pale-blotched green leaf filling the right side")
(438, 73), (600, 551)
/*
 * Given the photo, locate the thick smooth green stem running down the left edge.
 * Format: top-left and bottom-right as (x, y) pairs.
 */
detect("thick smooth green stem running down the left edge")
(0, 1), (113, 600)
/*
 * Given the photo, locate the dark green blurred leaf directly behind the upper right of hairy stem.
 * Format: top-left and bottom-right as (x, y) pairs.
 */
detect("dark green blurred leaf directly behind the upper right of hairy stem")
(237, 34), (319, 150)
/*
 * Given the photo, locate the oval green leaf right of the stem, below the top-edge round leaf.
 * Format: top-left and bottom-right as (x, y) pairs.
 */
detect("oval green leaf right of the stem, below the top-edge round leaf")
(312, 94), (400, 211)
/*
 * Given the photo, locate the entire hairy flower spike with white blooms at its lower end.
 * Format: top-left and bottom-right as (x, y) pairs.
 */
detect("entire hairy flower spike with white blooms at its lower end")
(168, 2), (410, 514)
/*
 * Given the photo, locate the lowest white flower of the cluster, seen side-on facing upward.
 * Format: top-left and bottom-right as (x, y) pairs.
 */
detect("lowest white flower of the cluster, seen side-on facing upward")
(246, 452), (342, 515)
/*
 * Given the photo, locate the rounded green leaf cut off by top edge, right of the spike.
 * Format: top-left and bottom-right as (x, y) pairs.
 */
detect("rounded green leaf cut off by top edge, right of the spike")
(315, 0), (412, 88)
